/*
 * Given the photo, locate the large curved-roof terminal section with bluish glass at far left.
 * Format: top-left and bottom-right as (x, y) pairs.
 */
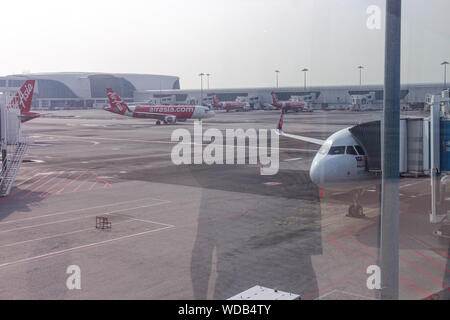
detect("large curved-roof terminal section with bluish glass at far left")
(0, 72), (180, 109)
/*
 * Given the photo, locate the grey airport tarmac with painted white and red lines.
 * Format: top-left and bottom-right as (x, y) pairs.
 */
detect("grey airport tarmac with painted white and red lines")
(0, 110), (450, 300)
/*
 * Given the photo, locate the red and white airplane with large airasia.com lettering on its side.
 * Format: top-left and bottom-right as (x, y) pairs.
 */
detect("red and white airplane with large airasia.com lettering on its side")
(104, 88), (215, 125)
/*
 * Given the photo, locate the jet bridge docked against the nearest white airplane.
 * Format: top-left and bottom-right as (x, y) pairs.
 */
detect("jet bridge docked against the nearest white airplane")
(350, 90), (450, 231)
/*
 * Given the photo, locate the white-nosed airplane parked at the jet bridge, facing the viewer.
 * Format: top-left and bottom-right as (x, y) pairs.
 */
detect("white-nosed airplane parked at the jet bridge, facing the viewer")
(276, 108), (377, 217)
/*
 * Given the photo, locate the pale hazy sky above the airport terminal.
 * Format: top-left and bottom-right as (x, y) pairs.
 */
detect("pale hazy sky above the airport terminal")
(0, 0), (450, 89)
